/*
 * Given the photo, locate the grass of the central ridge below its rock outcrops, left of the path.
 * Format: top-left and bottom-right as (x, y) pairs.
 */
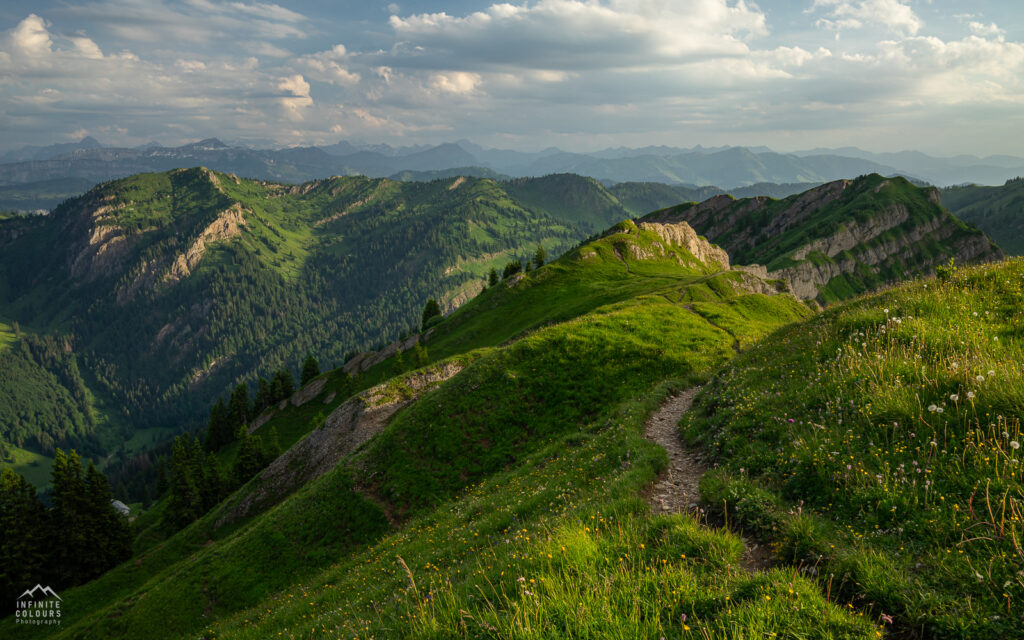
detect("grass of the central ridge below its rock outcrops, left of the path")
(2, 221), (888, 638)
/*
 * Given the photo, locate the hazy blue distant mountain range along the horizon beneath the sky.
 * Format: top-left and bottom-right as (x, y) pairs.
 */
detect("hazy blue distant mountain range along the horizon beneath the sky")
(0, 137), (1024, 210)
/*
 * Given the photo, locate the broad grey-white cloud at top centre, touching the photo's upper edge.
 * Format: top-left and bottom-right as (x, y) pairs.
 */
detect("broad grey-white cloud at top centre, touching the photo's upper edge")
(389, 0), (768, 70)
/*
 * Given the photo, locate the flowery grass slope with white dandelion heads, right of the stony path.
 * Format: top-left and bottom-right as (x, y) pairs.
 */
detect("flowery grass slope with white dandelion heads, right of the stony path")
(684, 260), (1024, 638)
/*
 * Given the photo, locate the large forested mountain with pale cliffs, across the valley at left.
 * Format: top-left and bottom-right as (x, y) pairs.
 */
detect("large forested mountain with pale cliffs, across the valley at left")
(0, 169), (623, 466)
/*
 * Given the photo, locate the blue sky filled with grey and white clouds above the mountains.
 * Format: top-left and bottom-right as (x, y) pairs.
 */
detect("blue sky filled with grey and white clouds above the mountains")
(0, 0), (1024, 156)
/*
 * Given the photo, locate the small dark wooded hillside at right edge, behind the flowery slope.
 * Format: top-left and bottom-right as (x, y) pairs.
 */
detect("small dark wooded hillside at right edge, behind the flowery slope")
(940, 178), (1024, 256)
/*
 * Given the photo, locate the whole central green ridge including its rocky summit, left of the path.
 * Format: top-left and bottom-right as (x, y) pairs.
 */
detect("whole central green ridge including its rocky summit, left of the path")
(2, 218), (871, 638)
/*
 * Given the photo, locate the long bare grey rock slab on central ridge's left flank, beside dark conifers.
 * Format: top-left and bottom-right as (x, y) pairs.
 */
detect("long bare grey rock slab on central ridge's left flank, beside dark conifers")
(214, 362), (462, 527)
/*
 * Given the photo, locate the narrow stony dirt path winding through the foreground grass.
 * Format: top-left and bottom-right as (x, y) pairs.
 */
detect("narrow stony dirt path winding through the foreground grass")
(644, 387), (771, 571)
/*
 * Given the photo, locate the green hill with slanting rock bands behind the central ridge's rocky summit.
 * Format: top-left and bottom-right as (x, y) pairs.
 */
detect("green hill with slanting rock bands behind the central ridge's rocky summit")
(643, 174), (1004, 302)
